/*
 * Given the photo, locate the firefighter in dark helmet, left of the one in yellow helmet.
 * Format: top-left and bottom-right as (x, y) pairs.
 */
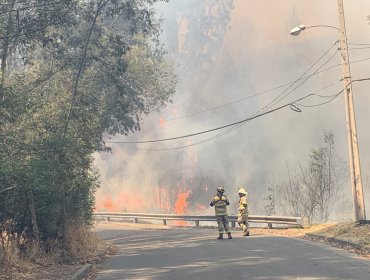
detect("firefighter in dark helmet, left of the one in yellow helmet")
(209, 186), (232, 239)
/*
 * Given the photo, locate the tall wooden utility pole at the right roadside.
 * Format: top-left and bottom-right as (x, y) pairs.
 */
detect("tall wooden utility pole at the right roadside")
(338, 0), (366, 222)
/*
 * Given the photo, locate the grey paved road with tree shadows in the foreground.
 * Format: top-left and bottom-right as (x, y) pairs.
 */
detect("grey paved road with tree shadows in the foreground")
(96, 226), (370, 280)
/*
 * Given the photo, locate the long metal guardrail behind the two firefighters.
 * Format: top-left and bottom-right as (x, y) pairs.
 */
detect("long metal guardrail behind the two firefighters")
(94, 212), (310, 228)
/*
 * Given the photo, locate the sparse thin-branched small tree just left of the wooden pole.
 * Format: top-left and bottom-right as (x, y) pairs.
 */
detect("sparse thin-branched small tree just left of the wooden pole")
(279, 131), (348, 222)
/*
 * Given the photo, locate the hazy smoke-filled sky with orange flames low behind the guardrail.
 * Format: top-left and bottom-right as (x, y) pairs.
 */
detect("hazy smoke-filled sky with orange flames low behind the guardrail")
(96, 0), (370, 220)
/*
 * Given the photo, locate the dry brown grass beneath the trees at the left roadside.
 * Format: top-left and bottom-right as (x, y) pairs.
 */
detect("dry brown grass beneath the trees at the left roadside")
(0, 223), (110, 280)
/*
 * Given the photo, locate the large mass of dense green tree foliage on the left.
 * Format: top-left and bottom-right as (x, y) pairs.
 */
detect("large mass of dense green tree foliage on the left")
(0, 0), (175, 260)
